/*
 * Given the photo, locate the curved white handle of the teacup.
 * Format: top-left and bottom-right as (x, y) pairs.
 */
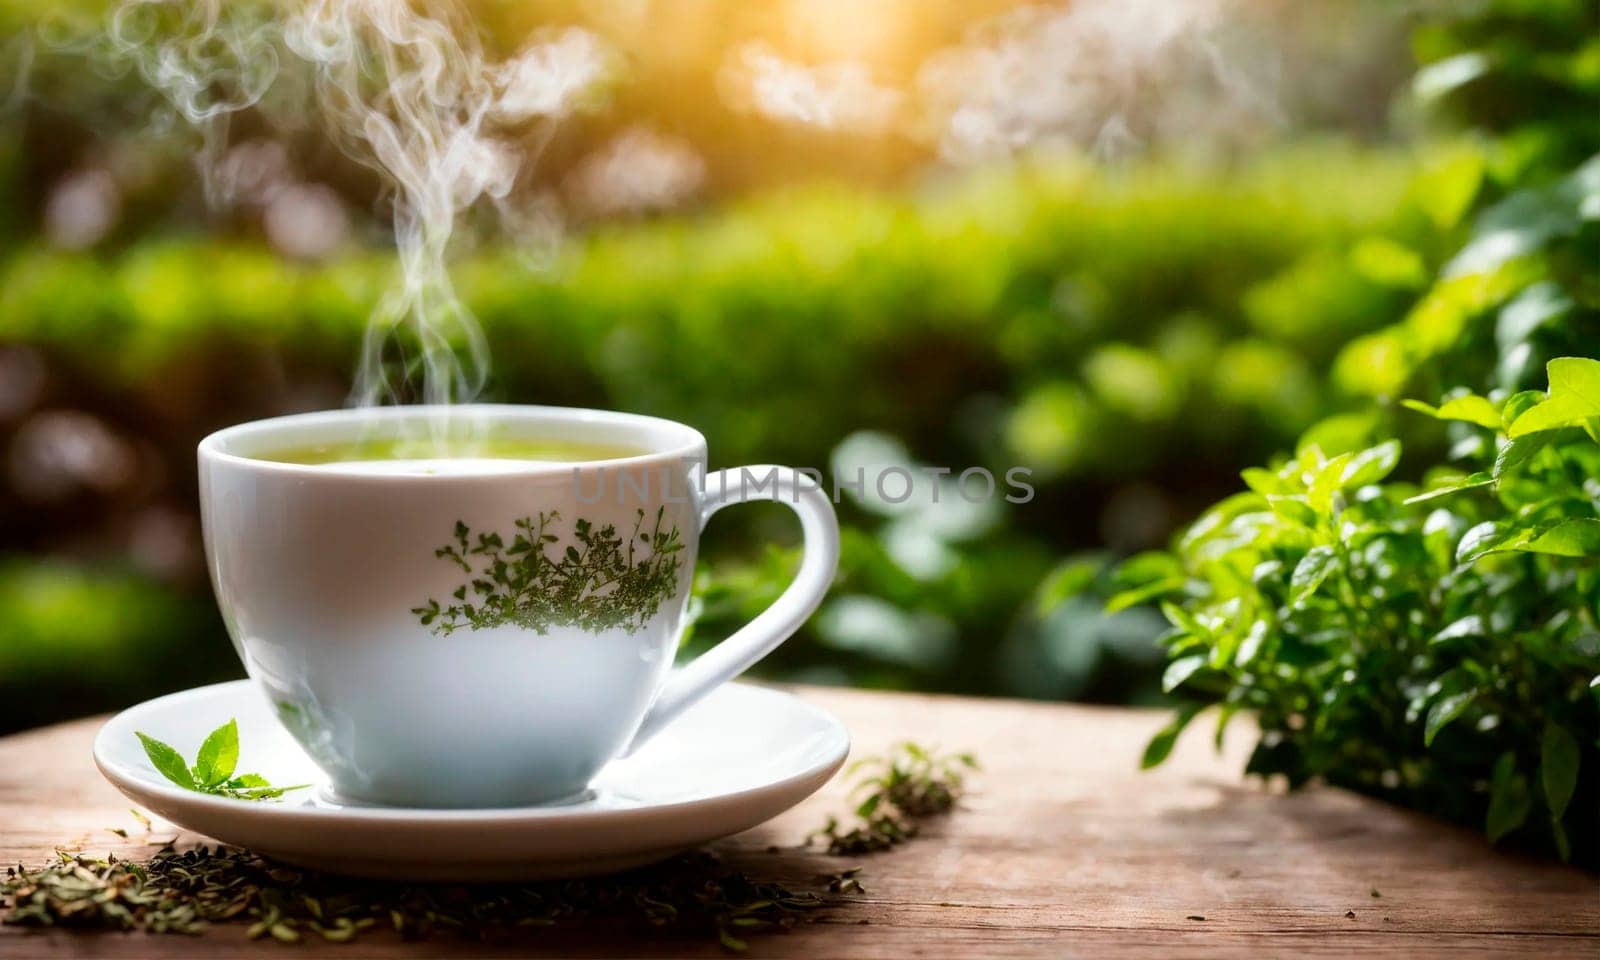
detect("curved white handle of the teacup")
(622, 466), (838, 757)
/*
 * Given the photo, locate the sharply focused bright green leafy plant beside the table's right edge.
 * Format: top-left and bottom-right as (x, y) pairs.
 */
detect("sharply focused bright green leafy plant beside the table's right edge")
(1109, 358), (1600, 864)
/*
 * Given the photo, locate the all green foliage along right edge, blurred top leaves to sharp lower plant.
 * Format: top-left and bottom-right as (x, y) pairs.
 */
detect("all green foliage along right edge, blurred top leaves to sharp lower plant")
(1094, 2), (1600, 866)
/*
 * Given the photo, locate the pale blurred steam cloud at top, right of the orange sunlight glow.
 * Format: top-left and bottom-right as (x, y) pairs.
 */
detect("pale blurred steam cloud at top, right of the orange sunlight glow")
(720, 0), (1282, 165)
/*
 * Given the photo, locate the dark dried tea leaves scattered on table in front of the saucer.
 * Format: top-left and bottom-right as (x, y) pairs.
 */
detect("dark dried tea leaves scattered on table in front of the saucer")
(9, 846), (838, 949)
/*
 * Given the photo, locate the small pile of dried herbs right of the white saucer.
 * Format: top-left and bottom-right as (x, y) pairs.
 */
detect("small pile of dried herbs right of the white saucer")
(806, 742), (978, 856)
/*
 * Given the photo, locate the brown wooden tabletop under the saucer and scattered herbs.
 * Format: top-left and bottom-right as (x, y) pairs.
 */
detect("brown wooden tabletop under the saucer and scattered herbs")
(0, 688), (1600, 960)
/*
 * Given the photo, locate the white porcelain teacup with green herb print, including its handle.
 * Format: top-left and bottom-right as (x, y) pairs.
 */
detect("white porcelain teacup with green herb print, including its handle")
(200, 405), (838, 806)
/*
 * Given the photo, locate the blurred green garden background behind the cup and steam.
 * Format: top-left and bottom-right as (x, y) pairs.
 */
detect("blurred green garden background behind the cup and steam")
(0, 3), (1600, 742)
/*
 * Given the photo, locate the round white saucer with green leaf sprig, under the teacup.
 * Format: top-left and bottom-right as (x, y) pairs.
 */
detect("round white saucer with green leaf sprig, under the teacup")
(94, 680), (850, 882)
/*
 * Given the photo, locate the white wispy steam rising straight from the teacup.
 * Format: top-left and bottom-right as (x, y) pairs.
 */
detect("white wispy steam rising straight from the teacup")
(91, 0), (610, 405)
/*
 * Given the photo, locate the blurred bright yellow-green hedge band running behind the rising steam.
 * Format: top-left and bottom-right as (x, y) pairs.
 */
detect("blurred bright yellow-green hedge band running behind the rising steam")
(0, 144), (1424, 475)
